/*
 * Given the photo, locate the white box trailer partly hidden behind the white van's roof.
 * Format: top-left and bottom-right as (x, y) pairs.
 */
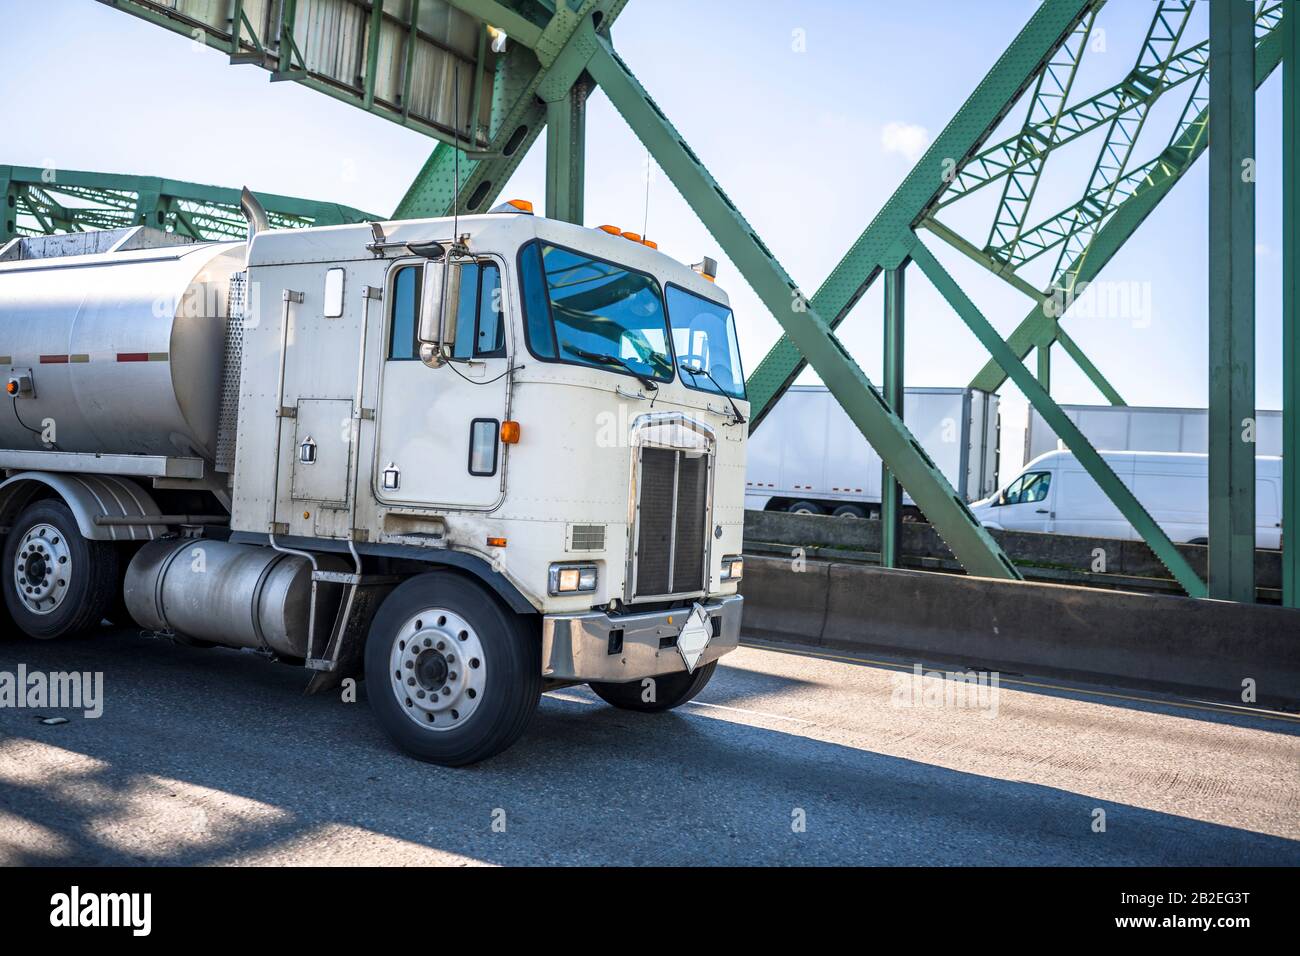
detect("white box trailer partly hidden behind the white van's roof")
(1024, 405), (1282, 462)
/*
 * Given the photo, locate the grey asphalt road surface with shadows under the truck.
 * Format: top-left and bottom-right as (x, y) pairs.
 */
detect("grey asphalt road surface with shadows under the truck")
(0, 630), (1300, 865)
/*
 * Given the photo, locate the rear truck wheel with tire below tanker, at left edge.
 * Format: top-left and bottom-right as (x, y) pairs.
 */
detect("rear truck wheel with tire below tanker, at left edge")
(0, 498), (118, 640)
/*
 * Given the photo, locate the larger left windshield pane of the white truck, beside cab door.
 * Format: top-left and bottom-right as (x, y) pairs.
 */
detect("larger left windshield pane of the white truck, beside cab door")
(519, 242), (672, 381)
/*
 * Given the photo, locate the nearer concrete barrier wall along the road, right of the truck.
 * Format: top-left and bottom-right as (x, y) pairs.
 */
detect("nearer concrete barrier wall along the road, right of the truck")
(741, 555), (1300, 709)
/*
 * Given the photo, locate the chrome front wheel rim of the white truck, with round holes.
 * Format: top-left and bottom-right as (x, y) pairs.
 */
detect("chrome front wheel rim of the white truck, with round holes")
(389, 607), (488, 731)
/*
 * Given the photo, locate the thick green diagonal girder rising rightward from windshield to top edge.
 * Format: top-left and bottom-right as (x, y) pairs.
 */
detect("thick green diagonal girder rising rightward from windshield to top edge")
(748, 0), (1100, 426)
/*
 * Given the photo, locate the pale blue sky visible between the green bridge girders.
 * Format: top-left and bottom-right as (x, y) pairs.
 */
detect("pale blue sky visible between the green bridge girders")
(0, 0), (1282, 462)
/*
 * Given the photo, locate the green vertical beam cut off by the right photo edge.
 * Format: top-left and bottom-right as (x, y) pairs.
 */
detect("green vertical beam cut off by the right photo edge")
(1284, 5), (1300, 607)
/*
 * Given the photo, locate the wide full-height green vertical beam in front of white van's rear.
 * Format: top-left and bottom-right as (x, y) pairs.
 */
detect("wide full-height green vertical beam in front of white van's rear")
(1209, 0), (1255, 602)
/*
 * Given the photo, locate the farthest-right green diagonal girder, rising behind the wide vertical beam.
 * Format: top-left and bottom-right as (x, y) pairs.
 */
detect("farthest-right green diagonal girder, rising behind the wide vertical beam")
(971, 8), (1283, 392)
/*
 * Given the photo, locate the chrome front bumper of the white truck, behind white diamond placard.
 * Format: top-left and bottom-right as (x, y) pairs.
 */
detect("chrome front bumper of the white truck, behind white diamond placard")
(542, 594), (744, 682)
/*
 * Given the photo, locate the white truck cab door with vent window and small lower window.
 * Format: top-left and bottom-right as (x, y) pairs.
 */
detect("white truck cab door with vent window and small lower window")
(372, 256), (510, 510)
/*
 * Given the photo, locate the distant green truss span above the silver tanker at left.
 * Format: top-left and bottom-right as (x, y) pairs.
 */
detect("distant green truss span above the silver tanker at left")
(0, 165), (378, 239)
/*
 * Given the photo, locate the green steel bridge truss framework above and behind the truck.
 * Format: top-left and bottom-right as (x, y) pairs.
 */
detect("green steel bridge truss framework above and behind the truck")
(22, 0), (1300, 606)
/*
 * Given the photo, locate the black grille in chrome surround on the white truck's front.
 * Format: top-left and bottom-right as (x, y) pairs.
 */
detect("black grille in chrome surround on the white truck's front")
(636, 447), (709, 597)
